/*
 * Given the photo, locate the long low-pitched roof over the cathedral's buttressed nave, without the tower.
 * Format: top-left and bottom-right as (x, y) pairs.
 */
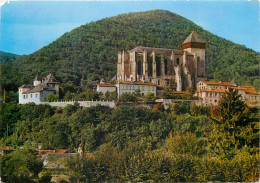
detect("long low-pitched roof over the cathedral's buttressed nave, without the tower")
(129, 46), (192, 55)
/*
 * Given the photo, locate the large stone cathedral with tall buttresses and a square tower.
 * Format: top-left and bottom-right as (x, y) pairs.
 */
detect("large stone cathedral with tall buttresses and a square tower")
(117, 31), (207, 91)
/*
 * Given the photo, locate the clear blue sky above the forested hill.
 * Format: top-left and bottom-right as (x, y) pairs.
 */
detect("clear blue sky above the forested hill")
(0, 0), (260, 55)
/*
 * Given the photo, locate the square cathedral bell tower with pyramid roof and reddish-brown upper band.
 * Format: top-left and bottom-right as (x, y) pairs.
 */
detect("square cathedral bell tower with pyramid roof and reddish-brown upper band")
(182, 31), (207, 80)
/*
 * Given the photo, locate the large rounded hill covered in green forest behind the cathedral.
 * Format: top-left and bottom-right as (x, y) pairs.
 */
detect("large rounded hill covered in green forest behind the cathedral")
(1, 10), (259, 90)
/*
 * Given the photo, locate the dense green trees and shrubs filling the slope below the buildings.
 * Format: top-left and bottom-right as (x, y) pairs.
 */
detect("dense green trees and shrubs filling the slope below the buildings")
(1, 90), (259, 182)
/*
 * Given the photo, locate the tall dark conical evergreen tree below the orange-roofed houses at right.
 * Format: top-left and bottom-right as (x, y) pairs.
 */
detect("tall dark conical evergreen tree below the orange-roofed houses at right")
(210, 89), (257, 158)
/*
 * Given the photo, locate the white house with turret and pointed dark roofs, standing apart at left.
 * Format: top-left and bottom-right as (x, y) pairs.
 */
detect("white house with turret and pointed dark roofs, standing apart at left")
(19, 74), (59, 104)
